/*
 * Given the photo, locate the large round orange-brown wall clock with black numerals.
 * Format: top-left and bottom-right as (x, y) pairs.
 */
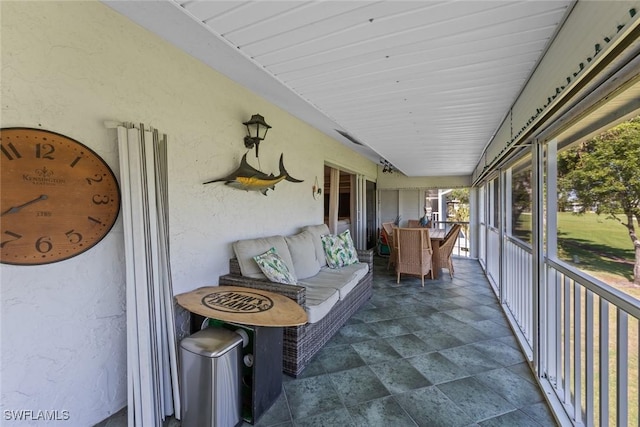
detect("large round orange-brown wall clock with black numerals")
(0, 128), (120, 265)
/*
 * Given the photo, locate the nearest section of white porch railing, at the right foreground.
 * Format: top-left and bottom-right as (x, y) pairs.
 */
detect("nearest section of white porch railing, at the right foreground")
(541, 260), (640, 426)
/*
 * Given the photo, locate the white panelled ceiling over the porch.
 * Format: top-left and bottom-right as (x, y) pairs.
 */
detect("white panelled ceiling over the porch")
(105, 0), (572, 176)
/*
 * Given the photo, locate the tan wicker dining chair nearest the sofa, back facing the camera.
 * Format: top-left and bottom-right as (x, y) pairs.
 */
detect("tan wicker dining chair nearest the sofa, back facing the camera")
(394, 228), (433, 287)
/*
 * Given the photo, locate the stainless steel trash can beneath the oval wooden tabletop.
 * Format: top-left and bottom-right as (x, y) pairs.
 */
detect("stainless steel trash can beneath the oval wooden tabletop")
(180, 328), (242, 427)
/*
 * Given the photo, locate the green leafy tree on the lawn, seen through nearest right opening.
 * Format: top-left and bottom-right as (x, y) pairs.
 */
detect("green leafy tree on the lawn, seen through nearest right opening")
(558, 116), (640, 285)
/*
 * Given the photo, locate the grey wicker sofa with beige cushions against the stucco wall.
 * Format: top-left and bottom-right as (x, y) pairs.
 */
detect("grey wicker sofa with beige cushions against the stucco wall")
(219, 224), (373, 377)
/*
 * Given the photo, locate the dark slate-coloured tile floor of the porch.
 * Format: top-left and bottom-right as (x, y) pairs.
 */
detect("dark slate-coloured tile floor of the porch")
(101, 258), (556, 427)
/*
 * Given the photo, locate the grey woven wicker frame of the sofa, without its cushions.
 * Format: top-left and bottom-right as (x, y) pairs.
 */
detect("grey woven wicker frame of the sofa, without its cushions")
(219, 251), (373, 377)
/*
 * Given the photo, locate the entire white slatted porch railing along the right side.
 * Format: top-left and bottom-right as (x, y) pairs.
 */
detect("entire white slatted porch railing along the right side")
(484, 229), (640, 426)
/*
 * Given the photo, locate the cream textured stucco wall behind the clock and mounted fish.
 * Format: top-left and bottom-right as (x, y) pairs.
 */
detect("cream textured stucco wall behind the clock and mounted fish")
(0, 1), (377, 426)
